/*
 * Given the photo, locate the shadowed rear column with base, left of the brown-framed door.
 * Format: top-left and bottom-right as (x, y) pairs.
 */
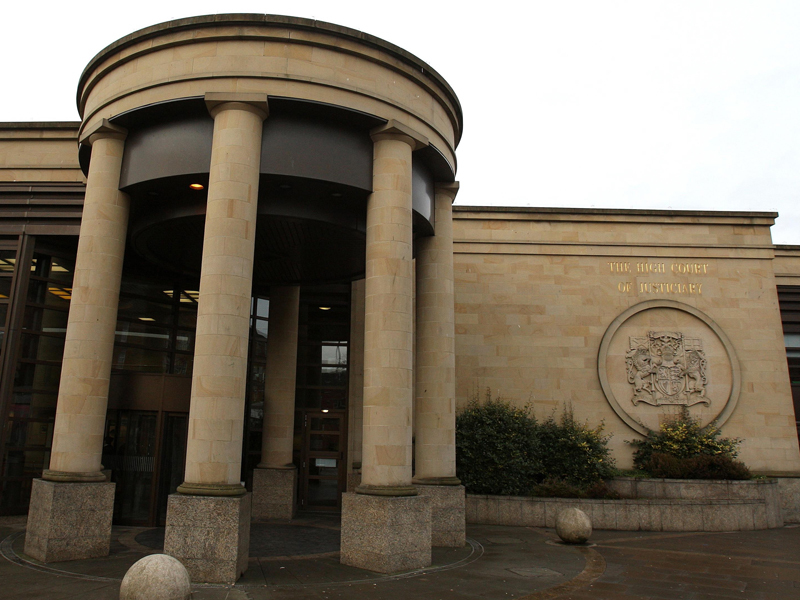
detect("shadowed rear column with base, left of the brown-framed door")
(253, 286), (300, 519)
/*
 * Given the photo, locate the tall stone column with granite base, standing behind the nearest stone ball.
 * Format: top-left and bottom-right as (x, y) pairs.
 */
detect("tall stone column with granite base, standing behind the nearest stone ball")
(164, 93), (268, 583)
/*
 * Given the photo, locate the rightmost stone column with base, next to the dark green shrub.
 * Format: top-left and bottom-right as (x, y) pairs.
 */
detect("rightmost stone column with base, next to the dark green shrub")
(414, 183), (466, 547)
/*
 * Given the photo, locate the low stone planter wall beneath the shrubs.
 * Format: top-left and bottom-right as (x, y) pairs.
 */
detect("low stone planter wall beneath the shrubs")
(466, 478), (783, 531)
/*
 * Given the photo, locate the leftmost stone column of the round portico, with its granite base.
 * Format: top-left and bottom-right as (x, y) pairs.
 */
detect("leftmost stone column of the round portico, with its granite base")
(25, 119), (130, 562)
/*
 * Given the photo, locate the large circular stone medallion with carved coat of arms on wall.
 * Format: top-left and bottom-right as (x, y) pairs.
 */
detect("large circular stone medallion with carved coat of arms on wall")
(597, 300), (741, 435)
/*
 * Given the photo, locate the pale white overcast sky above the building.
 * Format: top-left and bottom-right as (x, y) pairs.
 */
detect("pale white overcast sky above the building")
(6, 0), (800, 244)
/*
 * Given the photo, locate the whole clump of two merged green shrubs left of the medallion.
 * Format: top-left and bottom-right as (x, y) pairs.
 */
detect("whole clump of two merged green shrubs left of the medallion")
(456, 390), (614, 497)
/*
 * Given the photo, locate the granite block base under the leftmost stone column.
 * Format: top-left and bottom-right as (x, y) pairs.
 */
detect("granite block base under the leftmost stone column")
(25, 479), (115, 563)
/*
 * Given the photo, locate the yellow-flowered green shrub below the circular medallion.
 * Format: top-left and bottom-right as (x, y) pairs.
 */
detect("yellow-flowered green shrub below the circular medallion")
(628, 407), (750, 479)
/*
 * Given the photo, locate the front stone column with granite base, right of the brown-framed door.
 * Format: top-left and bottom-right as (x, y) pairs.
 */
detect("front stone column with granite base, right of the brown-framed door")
(341, 121), (431, 573)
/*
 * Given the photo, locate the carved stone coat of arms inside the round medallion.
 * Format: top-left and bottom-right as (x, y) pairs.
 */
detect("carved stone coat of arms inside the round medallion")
(625, 331), (710, 406)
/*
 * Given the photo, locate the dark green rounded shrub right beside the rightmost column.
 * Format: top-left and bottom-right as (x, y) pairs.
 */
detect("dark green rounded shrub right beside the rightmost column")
(456, 392), (541, 496)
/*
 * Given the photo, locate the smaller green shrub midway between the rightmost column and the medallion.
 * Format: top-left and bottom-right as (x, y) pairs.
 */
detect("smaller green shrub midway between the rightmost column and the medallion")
(538, 409), (615, 487)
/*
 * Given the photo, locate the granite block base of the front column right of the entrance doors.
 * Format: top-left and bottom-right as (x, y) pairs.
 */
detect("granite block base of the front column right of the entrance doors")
(340, 493), (431, 573)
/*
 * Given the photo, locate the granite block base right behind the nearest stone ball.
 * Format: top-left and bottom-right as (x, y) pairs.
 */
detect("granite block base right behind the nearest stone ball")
(164, 494), (251, 584)
